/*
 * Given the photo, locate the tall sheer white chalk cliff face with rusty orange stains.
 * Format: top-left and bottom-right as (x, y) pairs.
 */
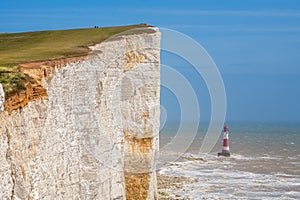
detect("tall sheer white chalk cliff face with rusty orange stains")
(0, 28), (160, 199)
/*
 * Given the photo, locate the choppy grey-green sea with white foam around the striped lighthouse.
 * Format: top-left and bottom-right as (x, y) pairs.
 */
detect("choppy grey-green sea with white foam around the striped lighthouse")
(158, 122), (300, 200)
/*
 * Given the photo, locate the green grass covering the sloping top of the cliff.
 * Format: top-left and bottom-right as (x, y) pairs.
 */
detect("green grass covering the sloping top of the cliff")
(0, 24), (148, 95)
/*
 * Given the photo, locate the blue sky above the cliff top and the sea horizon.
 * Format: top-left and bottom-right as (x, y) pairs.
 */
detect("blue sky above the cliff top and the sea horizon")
(0, 0), (300, 123)
